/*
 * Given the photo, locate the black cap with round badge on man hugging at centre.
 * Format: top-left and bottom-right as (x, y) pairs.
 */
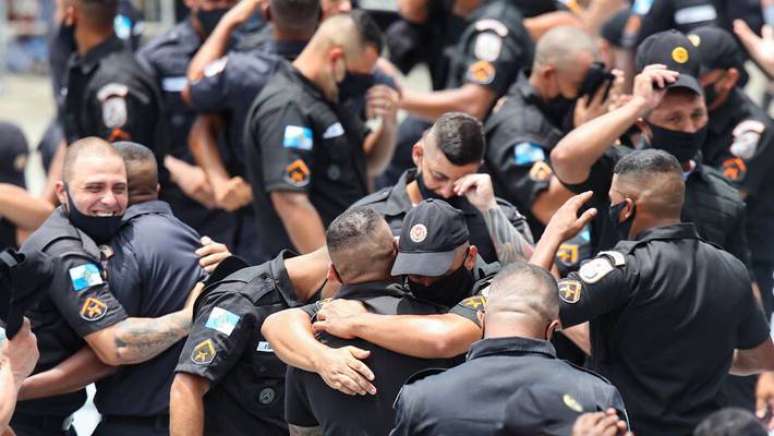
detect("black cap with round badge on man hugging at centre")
(392, 199), (470, 277)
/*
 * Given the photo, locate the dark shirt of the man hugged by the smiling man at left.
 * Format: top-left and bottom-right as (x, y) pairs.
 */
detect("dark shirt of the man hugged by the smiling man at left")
(94, 201), (204, 416)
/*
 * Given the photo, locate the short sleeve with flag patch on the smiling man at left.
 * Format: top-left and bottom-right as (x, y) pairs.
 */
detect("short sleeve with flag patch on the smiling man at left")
(49, 254), (127, 337)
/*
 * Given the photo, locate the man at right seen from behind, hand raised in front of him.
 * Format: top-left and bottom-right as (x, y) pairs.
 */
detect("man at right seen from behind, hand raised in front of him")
(532, 150), (774, 435)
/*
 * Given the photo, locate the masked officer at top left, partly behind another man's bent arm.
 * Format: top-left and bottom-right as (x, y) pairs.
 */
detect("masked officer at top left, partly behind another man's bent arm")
(137, 0), (235, 243)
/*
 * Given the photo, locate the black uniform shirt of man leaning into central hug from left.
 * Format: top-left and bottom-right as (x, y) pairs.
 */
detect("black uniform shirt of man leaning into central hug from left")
(175, 252), (299, 436)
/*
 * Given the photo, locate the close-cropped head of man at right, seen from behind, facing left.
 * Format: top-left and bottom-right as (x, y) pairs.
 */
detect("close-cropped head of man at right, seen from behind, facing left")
(611, 149), (685, 219)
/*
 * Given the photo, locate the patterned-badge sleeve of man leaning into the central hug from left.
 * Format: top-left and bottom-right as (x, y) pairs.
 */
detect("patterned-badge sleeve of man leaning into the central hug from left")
(175, 291), (259, 384)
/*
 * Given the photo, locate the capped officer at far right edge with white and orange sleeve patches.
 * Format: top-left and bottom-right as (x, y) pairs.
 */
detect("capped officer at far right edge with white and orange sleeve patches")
(688, 27), (774, 313)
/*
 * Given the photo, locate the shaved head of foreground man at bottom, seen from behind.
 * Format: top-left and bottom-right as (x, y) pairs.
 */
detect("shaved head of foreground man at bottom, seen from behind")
(485, 262), (559, 339)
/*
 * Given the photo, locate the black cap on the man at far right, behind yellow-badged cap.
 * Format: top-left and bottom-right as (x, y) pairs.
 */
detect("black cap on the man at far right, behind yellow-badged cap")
(688, 26), (745, 73)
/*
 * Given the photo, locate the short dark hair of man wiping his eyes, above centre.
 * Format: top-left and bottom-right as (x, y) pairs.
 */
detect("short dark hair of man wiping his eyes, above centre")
(429, 112), (486, 165)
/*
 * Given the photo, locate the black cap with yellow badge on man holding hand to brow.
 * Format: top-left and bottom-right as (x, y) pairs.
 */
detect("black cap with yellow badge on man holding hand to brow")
(635, 29), (703, 95)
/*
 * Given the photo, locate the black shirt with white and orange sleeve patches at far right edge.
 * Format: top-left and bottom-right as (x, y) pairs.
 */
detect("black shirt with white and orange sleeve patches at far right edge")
(702, 89), (774, 263)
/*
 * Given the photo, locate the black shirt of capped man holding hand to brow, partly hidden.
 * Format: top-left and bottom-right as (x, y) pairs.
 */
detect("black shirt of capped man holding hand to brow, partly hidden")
(565, 146), (750, 266)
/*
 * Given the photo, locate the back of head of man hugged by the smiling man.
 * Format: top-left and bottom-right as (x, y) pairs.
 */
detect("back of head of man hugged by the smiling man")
(113, 141), (159, 205)
